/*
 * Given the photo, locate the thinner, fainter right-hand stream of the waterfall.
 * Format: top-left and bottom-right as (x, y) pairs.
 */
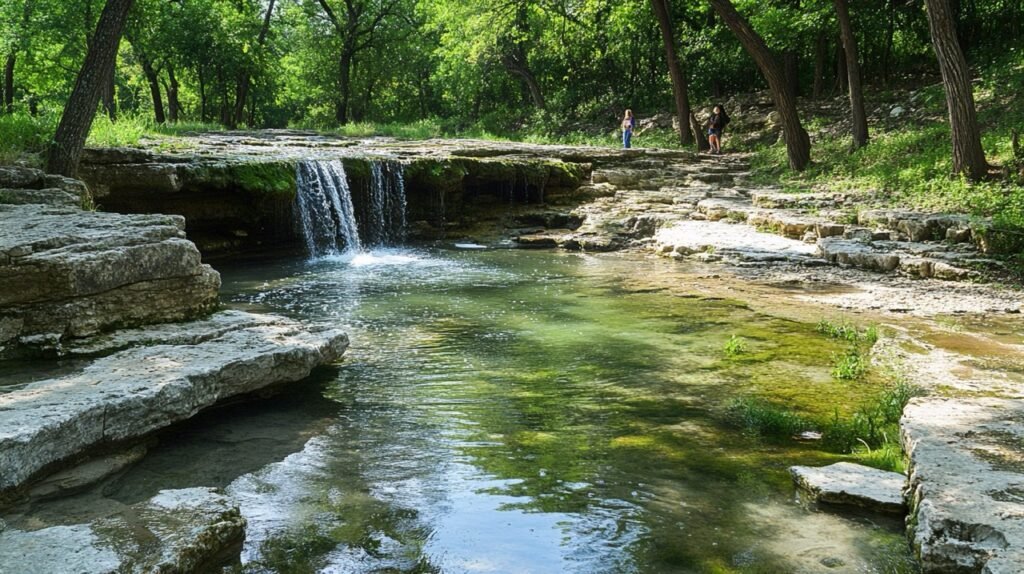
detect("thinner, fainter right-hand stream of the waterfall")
(359, 161), (406, 246)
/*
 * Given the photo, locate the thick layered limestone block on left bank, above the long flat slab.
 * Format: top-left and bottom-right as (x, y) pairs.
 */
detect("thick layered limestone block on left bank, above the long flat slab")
(0, 201), (220, 355)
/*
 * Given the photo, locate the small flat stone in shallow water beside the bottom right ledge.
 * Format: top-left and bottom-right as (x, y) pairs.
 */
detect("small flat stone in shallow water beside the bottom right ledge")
(790, 462), (906, 513)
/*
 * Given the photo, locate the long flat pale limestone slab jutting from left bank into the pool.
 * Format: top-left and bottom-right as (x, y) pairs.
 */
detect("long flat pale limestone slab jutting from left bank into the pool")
(0, 318), (348, 492)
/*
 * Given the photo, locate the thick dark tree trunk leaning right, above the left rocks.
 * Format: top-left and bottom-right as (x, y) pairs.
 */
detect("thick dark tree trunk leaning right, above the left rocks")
(46, 0), (133, 177)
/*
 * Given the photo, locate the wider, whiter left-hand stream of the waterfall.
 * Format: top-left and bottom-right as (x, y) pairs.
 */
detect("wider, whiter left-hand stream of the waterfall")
(296, 160), (362, 257)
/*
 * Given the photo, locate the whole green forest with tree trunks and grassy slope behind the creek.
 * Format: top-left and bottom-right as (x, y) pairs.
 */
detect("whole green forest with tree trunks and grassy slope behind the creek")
(0, 0), (1024, 252)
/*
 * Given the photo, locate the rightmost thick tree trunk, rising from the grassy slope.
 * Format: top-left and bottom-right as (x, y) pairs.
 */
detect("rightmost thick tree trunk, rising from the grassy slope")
(925, 0), (988, 180)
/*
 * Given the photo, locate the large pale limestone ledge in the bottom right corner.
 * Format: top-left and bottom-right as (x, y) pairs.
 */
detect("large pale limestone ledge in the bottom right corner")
(900, 397), (1024, 574)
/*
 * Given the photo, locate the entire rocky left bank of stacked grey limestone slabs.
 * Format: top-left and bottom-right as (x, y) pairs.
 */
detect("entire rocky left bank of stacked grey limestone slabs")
(0, 168), (348, 574)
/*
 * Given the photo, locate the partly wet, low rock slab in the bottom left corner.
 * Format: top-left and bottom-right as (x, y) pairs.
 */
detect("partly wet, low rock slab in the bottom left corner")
(0, 488), (246, 574)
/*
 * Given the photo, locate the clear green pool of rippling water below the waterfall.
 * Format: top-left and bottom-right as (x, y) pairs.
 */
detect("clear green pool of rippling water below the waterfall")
(12, 250), (916, 574)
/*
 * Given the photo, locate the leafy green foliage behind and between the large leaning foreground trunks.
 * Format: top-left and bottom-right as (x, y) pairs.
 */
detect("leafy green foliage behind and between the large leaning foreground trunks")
(0, 0), (1024, 134)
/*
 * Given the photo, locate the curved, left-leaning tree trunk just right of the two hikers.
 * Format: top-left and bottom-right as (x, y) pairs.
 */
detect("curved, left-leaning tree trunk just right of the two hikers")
(708, 0), (811, 171)
